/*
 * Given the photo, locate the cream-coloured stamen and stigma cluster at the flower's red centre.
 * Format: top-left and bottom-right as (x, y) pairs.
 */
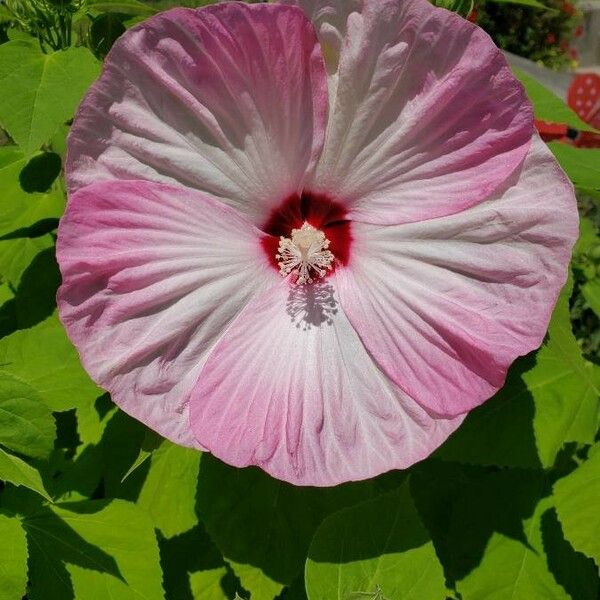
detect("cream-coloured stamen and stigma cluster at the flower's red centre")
(275, 222), (335, 285)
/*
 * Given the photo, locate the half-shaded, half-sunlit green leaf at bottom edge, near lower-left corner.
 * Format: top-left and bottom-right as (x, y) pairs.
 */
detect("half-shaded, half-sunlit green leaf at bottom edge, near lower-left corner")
(23, 500), (164, 600)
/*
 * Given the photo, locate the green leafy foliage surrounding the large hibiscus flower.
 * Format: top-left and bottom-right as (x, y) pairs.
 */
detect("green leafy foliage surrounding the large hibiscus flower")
(0, 0), (600, 600)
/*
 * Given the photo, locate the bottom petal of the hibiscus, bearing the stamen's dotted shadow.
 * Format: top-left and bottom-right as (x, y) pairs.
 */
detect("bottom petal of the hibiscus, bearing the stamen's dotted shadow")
(190, 281), (462, 486)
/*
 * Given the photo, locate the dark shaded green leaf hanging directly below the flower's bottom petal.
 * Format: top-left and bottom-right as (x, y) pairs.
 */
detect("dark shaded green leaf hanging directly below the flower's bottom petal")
(198, 454), (373, 600)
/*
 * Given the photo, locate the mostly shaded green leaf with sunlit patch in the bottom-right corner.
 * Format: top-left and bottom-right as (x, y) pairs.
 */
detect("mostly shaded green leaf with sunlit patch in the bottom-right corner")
(448, 470), (598, 600)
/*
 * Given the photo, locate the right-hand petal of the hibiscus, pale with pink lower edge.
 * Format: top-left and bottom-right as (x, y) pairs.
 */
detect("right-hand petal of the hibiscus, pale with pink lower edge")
(336, 136), (578, 417)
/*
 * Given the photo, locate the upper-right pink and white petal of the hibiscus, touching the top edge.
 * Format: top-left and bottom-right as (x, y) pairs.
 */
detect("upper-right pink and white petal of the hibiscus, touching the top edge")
(297, 0), (533, 224)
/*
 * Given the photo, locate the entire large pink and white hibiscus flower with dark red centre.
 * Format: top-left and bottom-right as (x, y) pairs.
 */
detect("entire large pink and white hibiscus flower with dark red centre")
(58, 0), (577, 486)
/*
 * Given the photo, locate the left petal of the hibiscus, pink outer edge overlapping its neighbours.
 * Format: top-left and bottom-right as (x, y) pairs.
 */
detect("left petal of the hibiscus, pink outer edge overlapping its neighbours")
(57, 181), (278, 446)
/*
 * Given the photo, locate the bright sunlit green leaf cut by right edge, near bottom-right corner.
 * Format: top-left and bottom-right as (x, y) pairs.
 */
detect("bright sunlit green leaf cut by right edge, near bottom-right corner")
(554, 444), (600, 566)
